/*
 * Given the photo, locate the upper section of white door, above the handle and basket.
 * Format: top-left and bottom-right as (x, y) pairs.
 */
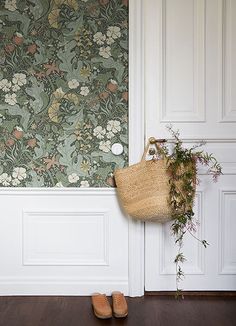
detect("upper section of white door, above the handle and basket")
(144, 0), (236, 139)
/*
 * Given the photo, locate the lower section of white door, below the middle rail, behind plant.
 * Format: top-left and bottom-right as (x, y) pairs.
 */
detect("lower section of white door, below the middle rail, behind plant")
(145, 175), (236, 291)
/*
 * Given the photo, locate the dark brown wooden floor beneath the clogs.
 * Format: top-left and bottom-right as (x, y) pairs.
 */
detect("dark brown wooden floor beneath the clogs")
(0, 296), (236, 326)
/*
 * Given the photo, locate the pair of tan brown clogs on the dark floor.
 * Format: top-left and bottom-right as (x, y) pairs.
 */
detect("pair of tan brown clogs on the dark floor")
(92, 291), (128, 319)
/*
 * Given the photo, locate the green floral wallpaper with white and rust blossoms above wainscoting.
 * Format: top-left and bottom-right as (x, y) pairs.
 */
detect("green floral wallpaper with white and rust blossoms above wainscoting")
(0, 0), (128, 187)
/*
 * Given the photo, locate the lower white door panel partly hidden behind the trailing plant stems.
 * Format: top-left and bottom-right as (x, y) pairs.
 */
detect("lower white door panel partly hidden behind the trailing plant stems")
(159, 190), (205, 275)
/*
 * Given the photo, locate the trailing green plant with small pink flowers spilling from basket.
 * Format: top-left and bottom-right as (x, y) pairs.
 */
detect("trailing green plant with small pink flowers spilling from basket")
(152, 125), (222, 297)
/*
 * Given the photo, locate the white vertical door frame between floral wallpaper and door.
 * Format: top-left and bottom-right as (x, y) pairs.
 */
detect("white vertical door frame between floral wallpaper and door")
(128, 0), (145, 297)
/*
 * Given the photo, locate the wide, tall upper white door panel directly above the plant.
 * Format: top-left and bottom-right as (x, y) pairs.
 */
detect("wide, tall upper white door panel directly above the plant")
(160, 0), (205, 122)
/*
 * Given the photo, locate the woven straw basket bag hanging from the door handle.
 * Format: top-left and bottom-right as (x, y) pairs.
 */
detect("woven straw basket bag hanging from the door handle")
(114, 137), (171, 223)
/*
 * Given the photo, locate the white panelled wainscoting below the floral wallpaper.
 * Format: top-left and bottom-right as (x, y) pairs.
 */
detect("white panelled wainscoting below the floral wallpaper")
(0, 188), (129, 295)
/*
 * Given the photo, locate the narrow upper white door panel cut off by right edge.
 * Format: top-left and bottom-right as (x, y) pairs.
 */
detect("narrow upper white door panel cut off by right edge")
(219, 0), (236, 123)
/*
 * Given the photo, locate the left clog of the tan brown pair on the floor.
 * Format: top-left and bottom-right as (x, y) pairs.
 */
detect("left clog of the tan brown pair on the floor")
(92, 293), (112, 319)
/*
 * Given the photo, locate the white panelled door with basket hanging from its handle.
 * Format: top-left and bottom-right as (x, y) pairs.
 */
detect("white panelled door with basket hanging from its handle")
(144, 0), (236, 291)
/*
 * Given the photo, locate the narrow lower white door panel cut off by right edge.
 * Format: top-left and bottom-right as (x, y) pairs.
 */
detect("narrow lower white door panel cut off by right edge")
(219, 189), (236, 275)
